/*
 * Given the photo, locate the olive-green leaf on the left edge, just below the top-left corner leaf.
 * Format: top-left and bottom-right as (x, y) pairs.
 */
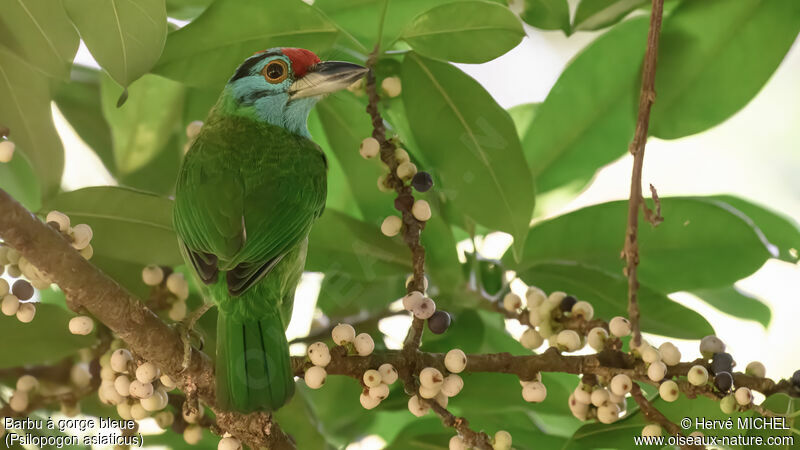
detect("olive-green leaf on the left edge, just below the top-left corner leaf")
(0, 46), (64, 198)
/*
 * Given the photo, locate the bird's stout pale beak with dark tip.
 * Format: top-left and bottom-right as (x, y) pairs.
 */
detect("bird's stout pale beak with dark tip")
(289, 61), (369, 100)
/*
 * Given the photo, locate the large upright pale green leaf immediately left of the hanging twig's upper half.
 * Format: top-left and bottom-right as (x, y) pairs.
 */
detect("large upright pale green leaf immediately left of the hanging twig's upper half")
(522, 18), (648, 195)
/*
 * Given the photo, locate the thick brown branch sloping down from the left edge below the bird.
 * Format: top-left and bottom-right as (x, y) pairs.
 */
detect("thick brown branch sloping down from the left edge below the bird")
(0, 189), (294, 449)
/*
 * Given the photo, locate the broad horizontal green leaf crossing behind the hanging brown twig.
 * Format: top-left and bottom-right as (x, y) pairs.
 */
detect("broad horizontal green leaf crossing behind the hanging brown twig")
(505, 197), (770, 292)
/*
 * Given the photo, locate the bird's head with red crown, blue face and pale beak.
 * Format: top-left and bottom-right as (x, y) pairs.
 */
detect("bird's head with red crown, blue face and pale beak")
(223, 47), (367, 136)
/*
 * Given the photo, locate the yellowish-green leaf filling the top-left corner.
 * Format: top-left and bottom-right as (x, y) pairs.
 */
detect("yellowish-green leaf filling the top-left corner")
(0, 0), (79, 78)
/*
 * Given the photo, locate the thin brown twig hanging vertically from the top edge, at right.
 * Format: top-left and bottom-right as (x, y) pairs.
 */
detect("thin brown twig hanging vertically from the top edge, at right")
(623, 0), (664, 345)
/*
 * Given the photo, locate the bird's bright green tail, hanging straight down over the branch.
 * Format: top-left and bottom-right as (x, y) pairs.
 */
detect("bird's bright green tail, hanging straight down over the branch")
(217, 310), (294, 412)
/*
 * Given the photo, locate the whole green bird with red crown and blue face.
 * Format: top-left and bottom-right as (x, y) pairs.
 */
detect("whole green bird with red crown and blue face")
(174, 48), (367, 412)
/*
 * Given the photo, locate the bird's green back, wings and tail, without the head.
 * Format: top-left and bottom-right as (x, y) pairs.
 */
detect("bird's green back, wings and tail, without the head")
(174, 110), (326, 412)
